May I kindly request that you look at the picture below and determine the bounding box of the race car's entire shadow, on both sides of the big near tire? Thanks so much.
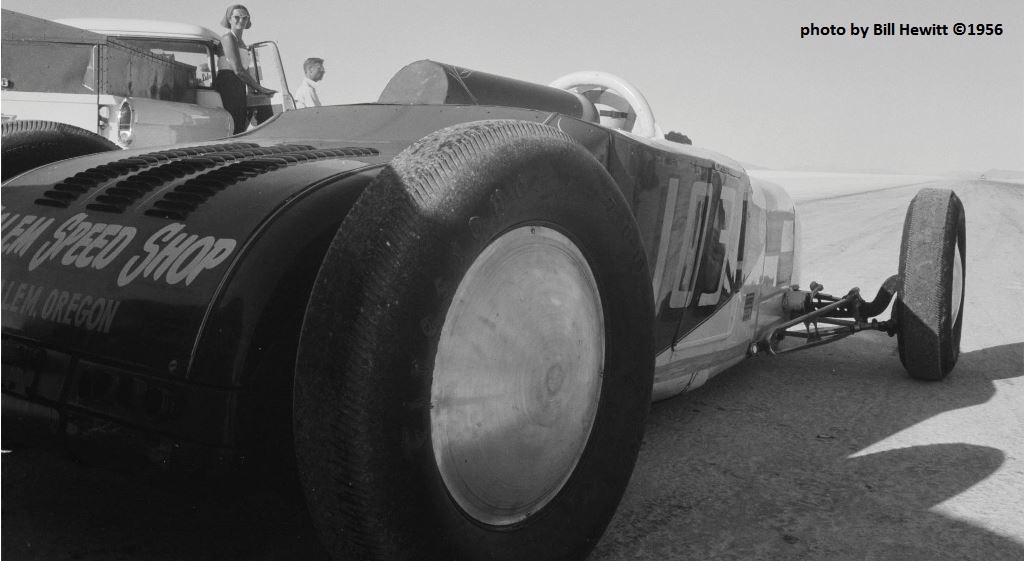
[2,335,1024,561]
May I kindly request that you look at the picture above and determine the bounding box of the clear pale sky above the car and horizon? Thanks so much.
[6,0,1024,174]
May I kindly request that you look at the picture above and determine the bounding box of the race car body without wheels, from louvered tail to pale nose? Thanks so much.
[2,62,799,456]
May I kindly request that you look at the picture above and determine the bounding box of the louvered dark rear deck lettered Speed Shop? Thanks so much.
[2,141,381,375]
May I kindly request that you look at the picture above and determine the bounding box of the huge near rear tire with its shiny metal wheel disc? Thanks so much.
[295,121,653,561]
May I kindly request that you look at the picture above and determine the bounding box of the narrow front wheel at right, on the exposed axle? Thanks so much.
[894,188,967,380]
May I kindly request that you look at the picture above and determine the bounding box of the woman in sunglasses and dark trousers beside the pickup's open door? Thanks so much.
[213,4,275,134]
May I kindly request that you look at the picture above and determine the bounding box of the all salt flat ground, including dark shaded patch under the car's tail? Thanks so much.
[2,172,1024,561]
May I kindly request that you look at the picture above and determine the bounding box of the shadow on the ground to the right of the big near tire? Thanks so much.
[591,334,1024,561]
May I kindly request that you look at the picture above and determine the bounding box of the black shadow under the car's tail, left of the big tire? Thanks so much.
[0,425,328,561]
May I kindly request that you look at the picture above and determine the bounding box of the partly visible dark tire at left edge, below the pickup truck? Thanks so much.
[0,120,119,181]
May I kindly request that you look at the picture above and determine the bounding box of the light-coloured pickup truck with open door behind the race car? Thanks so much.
[2,9,295,179]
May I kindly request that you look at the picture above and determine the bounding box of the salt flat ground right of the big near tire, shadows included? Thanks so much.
[591,173,1024,561]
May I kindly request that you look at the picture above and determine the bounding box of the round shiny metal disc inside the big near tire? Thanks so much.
[430,226,604,525]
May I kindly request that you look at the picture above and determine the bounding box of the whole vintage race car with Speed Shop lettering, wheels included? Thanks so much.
[2,60,965,560]
